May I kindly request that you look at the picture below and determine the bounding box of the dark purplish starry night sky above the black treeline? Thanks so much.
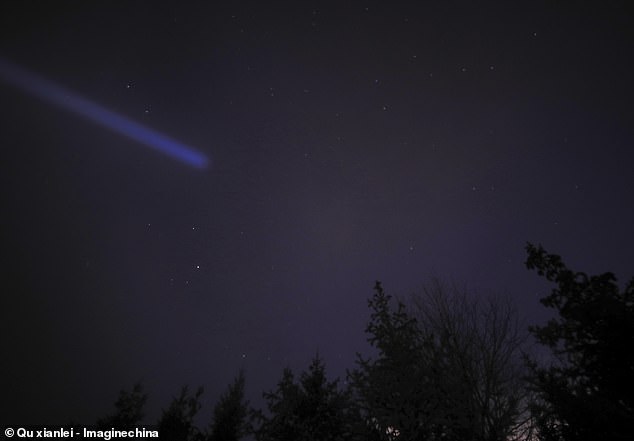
[0,1,634,424]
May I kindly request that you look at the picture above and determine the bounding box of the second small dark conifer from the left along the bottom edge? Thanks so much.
[158,386,204,441]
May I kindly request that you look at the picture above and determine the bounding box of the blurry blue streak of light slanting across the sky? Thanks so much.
[0,58,209,169]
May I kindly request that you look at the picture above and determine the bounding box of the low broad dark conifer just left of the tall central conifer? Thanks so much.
[253,356,351,441]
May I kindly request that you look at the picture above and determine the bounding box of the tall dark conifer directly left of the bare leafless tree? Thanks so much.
[349,281,444,440]
